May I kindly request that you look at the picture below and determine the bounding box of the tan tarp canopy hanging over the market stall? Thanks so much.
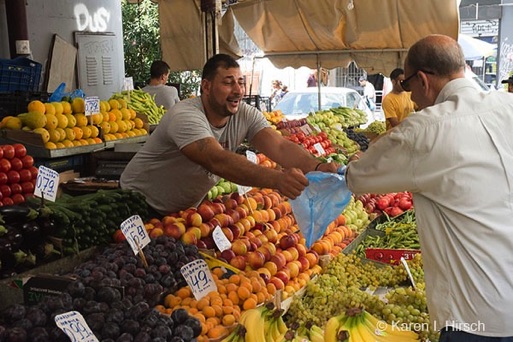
[159,0,459,74]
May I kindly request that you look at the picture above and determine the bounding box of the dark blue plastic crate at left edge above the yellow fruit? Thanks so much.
[0,57,42,92]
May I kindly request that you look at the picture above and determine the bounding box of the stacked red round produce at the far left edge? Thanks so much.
[0,144,38,206]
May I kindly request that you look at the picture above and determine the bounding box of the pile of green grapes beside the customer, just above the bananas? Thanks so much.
[284,253,438,341]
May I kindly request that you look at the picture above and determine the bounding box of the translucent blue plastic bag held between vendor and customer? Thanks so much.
[290,168,352,248]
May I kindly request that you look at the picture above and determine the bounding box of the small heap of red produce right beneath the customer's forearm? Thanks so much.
[358,191,413,217]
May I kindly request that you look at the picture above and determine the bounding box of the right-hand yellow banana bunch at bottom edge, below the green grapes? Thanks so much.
[324,309,420,342]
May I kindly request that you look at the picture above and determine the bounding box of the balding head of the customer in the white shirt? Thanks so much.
[404,34,465,109]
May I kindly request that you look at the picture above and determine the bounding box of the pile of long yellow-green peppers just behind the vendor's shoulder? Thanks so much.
[111,89,166,125]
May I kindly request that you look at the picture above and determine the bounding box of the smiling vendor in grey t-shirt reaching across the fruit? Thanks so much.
[120,54,339,215]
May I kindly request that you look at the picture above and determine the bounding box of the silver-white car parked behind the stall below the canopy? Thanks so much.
[273,87,374,124]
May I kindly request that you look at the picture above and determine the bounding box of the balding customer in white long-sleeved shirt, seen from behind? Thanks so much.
[346,35,513,342]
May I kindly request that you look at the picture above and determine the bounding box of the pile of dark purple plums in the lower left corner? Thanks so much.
[0,236,201,342]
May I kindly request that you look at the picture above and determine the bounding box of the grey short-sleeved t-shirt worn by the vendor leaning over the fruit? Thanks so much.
[120,97,269,214]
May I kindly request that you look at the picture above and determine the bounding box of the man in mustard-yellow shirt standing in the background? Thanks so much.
[381,68,415,130]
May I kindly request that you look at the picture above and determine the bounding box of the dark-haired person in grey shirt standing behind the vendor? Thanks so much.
[142,61,180,109]
